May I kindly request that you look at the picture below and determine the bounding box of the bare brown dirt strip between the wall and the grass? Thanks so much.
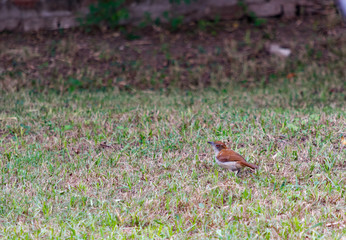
[0,14,345,92]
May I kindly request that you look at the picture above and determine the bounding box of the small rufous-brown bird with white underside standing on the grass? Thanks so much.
[208,141,258,174]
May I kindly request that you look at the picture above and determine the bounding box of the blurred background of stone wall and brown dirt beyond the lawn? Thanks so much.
[0,0,345,93]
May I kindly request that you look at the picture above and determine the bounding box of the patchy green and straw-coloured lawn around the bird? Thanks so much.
[0,66,346,239]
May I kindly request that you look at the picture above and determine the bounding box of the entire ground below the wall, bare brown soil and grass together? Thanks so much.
[0,14,346,239]
